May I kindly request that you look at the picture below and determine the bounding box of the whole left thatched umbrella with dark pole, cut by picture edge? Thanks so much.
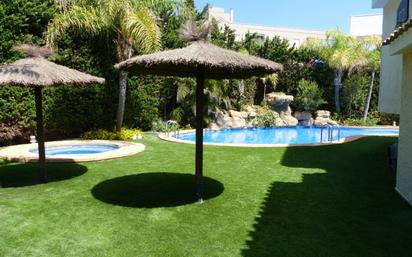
[0,45,104,182]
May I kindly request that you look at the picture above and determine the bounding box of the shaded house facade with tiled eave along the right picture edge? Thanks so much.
[372,0,412,205]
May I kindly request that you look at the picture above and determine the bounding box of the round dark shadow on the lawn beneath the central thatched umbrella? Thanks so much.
[92,172,224,208]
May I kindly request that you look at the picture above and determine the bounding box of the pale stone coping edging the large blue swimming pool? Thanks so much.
[159,126,399,148]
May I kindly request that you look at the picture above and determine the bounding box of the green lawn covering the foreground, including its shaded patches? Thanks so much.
[0,137,412,257]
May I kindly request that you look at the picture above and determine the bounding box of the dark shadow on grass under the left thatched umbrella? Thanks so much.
[0,163,87,188]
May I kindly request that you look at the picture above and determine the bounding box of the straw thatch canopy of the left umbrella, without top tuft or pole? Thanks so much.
[0,56,104,87]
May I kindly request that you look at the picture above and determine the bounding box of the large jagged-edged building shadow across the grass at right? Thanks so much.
[242,138,412,257]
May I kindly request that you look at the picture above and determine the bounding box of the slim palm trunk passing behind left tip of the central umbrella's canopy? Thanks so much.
[116,35,133,131]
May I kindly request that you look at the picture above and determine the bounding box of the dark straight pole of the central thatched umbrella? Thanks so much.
[196,70,205,203]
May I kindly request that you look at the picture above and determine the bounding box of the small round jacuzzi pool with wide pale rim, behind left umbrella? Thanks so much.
[0,140,145,162]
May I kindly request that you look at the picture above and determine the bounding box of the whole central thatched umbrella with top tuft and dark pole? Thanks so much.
[115,22,283,202]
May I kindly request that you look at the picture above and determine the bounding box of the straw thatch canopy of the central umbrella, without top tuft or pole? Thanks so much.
[115,40,283,79]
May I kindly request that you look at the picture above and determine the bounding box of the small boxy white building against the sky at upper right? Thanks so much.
[349,14,383,38]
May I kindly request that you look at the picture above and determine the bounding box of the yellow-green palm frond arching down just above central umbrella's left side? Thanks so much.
[121,8,160,53]
